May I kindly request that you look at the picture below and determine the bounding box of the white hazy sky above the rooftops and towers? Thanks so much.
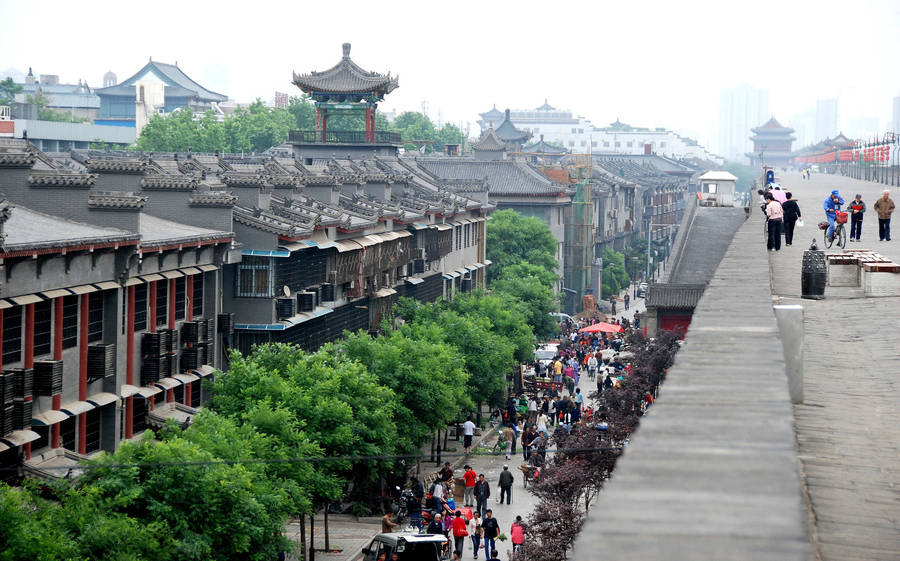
[0,0,900,149]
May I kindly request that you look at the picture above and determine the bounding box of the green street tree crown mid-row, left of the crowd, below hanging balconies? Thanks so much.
[334,324,473,452]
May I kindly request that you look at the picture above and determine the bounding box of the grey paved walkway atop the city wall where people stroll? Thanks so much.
[768,174,900,561]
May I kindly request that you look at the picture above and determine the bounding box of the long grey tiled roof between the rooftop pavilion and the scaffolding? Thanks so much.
[415,158,566,196]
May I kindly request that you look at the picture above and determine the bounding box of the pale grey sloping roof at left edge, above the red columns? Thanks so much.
[3,198,138,248]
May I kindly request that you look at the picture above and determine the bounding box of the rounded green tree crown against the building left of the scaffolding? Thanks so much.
[487,209,557,282]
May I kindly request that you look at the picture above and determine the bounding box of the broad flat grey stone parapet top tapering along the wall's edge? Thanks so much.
[572,211,810,561]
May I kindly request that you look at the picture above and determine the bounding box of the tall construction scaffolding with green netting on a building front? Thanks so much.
[563,154,599,314]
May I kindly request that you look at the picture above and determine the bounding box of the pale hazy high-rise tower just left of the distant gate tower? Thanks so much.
[718,84,771,160]
